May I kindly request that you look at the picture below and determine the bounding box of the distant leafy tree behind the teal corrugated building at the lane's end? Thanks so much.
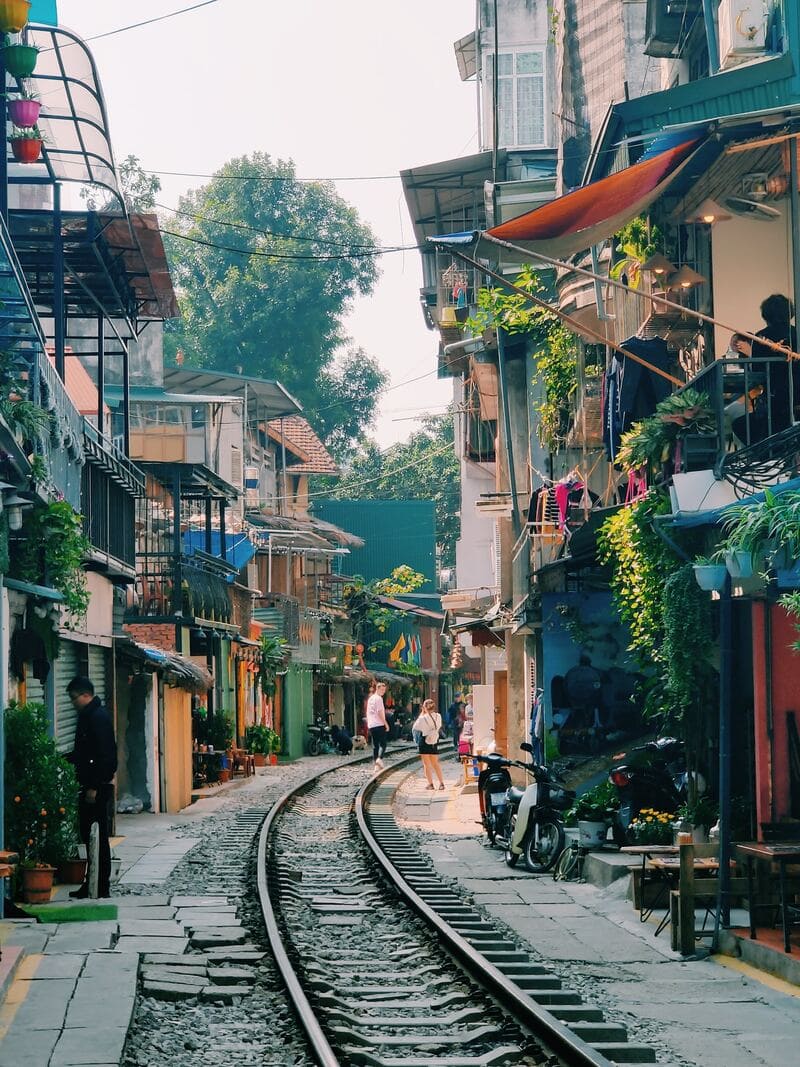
[315,416,461,567]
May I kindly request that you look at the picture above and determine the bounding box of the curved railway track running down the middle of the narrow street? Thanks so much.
[257,757,655,1067]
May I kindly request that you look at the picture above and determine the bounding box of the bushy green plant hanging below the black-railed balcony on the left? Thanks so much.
[12,500,90,625]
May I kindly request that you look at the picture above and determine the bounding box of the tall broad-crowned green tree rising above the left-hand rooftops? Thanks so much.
[164,152,380,451]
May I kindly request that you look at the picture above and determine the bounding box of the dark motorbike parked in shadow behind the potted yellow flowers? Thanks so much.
[608,737,706,845]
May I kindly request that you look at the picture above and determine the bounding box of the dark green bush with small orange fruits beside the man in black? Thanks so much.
[4,703,78,866]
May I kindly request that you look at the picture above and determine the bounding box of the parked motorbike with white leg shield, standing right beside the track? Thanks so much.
[477,742,575,874]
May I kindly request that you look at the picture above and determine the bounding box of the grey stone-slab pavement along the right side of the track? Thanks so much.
[398,761,800,1067]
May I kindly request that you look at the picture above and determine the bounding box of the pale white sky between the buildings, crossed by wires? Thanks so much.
[59,0,478,447]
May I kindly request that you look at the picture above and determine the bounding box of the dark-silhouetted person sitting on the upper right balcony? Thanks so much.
[732,293,800,445]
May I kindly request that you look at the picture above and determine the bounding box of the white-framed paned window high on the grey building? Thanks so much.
[486,50,546,148]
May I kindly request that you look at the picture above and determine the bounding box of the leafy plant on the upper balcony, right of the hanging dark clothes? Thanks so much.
[617,388,717,474]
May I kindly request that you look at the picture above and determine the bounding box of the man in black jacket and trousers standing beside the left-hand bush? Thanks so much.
[67,675,116,898]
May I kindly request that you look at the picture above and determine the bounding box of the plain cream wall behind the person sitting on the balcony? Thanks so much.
[711,201,793,359]
